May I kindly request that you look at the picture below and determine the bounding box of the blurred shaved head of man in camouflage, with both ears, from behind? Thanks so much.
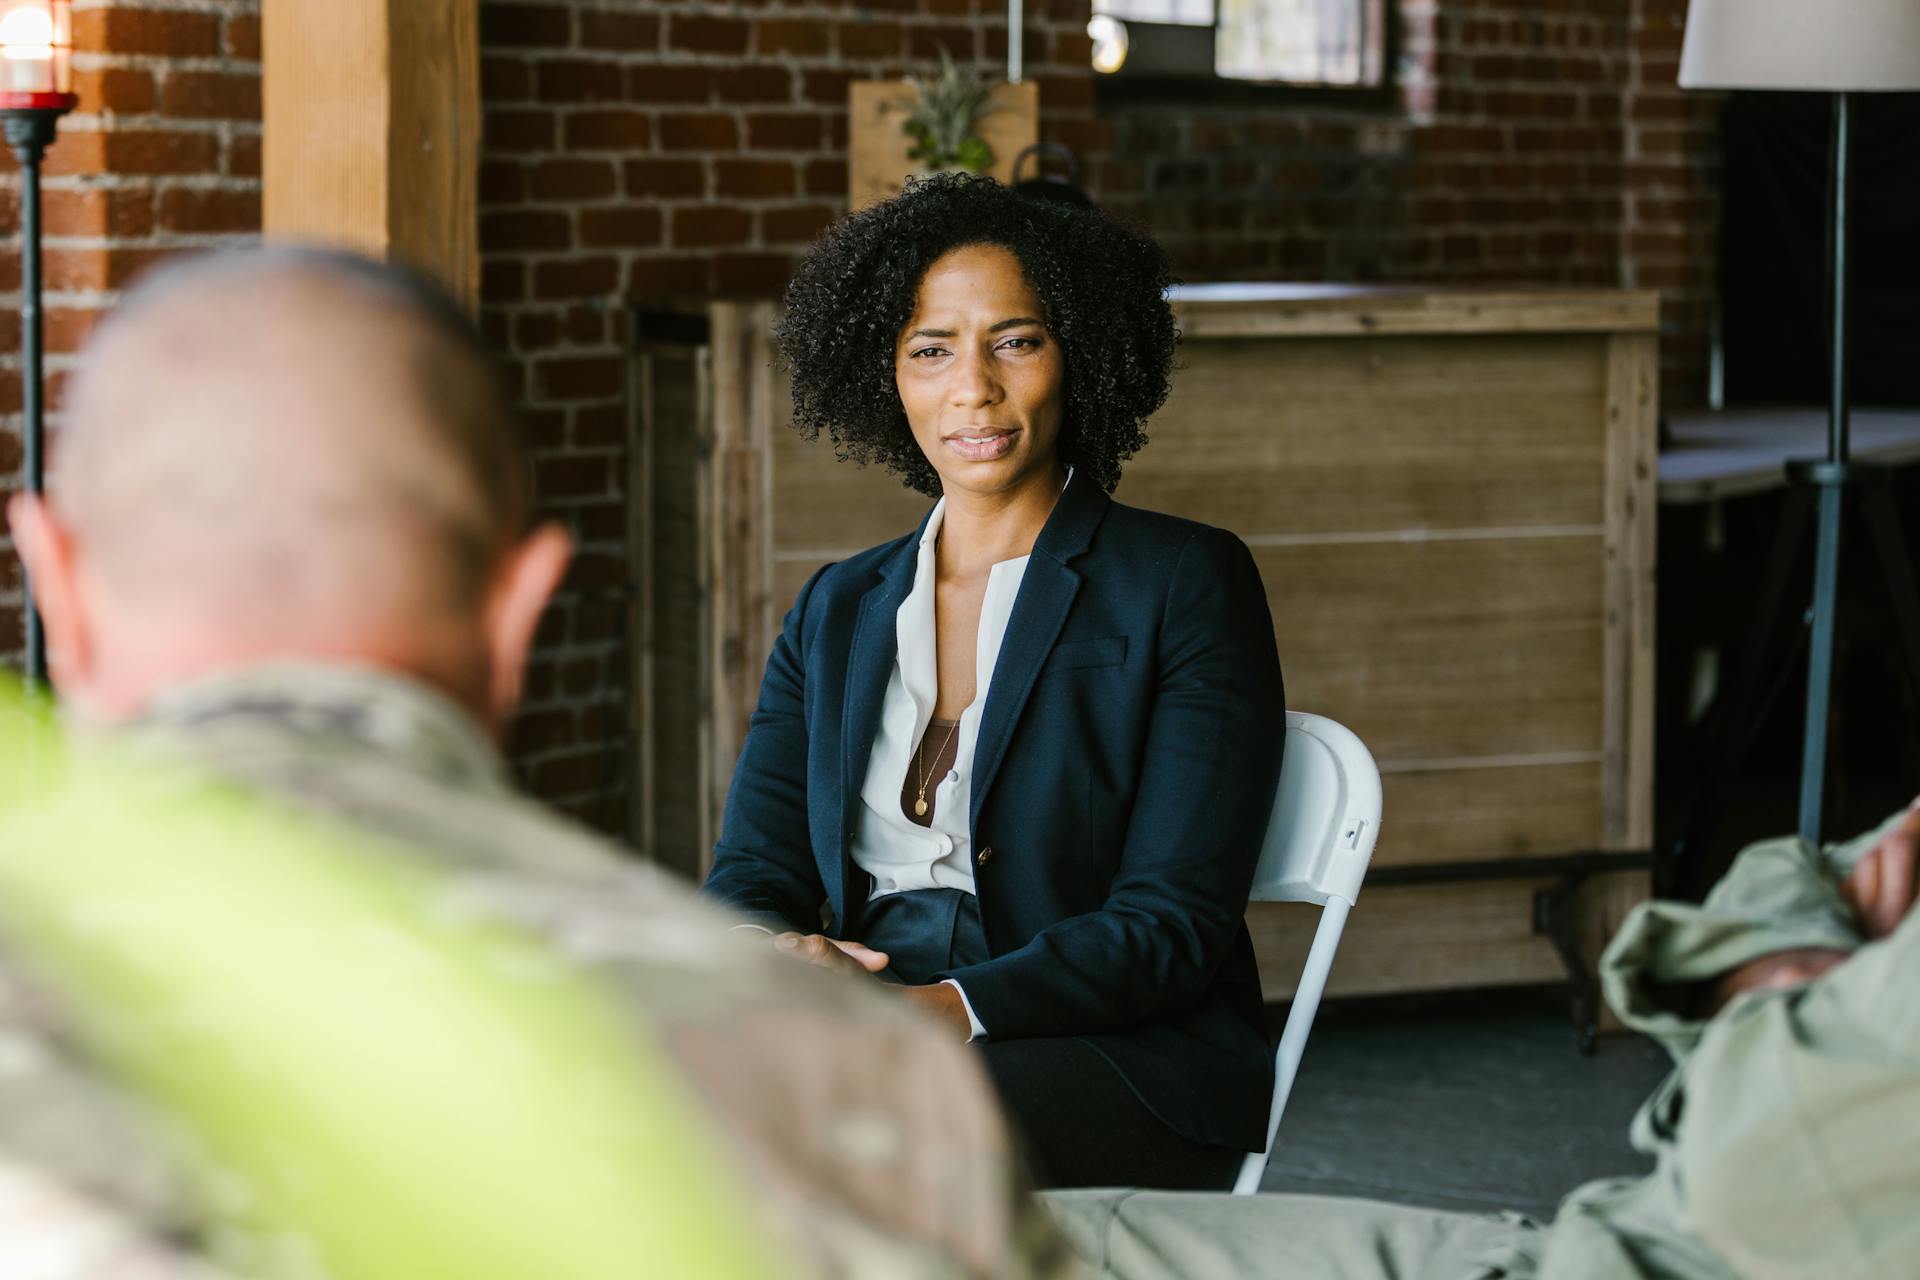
[10,249,568,723]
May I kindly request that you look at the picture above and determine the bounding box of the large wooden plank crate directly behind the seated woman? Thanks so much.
[636,286,1657,996]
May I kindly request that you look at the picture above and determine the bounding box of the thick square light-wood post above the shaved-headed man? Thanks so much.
[261,0,480,307]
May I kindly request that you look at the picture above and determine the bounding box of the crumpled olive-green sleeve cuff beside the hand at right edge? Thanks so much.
[1601,810,1905,1055]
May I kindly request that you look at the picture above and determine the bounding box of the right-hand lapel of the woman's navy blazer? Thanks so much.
[968,476,1112,823]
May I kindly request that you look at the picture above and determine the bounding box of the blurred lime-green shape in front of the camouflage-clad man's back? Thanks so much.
[0,685,778,1280]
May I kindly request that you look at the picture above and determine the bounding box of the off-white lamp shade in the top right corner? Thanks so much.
[1680,0,1920,92]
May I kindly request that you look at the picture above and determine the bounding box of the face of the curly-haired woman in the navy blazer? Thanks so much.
[893,244,1066,493]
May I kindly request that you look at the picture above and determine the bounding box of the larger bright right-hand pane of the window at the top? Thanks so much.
[1213,0,1382,84]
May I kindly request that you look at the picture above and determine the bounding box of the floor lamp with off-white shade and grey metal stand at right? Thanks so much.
[1680,0,1920,844]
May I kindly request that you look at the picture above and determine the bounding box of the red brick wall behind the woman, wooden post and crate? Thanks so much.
[0,0,1715,825]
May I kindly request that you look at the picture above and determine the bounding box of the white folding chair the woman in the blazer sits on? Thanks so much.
[1233,712,1380,1196]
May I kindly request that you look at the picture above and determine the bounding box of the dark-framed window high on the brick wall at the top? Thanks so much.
[1087,0,1386,90]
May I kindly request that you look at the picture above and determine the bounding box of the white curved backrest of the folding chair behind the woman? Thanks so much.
[1252,712,1380,906]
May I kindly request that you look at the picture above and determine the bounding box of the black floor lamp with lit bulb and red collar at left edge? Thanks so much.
[0,0,79,687]
